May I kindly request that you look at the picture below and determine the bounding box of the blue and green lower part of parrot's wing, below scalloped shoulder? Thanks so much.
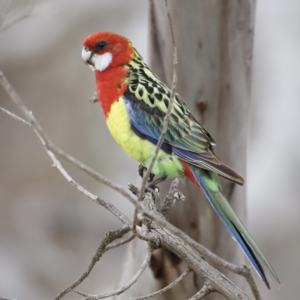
[123,92,244,184]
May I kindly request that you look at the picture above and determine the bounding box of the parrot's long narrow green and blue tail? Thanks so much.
[189,165,280,288]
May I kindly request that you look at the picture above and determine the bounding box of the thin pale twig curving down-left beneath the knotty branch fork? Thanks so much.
[80,250,151,300]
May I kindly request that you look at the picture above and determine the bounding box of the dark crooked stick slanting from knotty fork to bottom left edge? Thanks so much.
[54,226,130,300]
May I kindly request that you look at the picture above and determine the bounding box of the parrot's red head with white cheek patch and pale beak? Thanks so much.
[82,31,133,72]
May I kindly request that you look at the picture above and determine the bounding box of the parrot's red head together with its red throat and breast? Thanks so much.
[82,32,134,117]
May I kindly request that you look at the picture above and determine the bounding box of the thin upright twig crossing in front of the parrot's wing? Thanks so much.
[138,0,178,201]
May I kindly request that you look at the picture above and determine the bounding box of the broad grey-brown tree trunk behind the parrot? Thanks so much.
[115,0,255,300]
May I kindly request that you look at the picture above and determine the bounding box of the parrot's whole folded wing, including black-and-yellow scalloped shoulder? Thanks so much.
[123,69,244,184]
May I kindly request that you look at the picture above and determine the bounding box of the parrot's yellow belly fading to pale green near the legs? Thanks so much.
[106,97,183,177]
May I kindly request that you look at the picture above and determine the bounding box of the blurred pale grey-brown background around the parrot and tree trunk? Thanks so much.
[0,0,300,300]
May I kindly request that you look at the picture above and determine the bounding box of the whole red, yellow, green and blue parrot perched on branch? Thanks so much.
[81,31,280,289]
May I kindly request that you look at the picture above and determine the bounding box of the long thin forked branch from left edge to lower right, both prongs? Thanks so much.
[0,72,259,299]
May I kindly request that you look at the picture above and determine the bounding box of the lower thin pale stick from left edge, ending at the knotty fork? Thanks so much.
[0,107,131,227]
